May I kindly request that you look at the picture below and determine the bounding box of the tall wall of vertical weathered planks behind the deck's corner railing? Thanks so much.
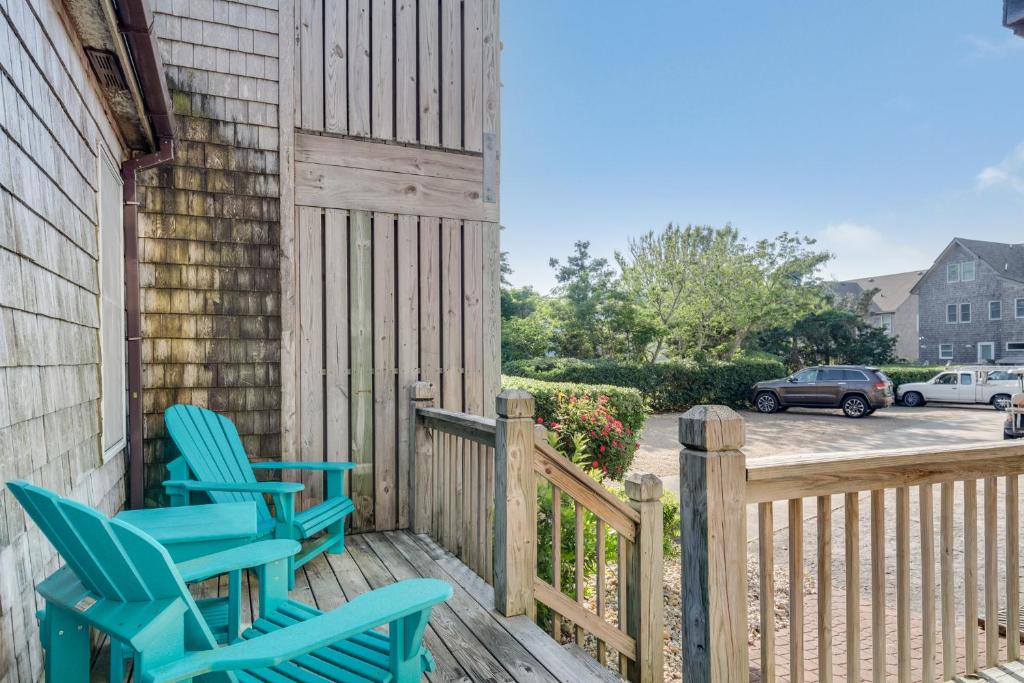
[281,0,500,529]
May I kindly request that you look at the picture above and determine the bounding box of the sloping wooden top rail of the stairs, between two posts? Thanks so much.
[534,425,640,542]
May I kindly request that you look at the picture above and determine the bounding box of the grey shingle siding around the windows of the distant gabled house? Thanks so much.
[918,244,1024,364]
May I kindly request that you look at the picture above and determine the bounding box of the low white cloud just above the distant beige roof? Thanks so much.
[816,221,935,280]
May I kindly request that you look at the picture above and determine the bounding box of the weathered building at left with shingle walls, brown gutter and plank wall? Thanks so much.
[0,0,500,681]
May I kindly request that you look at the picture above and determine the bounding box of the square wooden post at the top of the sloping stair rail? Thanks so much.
[495,389,537,617]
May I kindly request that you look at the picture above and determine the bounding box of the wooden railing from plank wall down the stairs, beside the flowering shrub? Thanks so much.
[411,382,665,681]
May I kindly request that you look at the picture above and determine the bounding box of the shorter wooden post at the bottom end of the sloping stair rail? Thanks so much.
[626,472,665,683]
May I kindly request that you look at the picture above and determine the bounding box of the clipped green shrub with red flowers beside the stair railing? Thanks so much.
[502,377,647,479]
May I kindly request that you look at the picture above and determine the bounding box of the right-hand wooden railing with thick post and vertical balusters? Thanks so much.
[680,407,1024,682]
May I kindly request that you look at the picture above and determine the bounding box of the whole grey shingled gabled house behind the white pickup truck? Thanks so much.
[912,238,1024,365]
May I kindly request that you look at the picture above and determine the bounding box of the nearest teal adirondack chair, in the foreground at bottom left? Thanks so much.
[7,481,452,683]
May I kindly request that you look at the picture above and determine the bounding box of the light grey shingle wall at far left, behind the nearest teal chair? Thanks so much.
[0,0,126,682]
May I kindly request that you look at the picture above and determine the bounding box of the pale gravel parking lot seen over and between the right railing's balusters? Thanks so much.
[633,405,1005,681]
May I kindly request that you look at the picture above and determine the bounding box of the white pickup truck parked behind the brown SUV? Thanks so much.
[896,368,1019,411]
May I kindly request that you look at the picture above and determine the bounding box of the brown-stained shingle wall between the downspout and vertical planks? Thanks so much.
[139,0,281,505]
